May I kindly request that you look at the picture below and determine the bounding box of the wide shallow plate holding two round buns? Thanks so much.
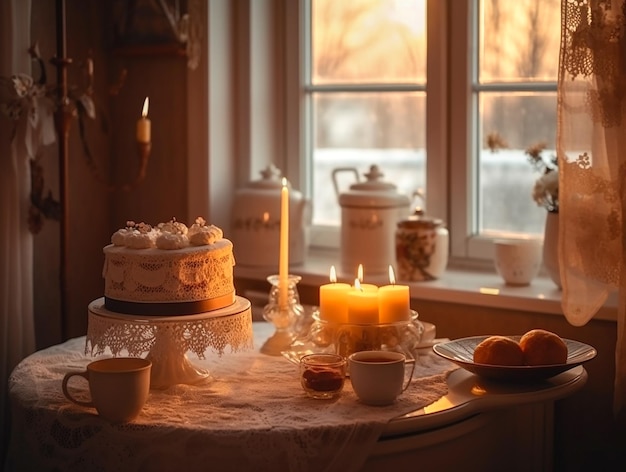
[433,336,597,382]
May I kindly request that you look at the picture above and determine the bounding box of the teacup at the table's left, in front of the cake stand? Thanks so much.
[62,357,152,423]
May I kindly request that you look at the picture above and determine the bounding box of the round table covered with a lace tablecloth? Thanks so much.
[7,323,587,472]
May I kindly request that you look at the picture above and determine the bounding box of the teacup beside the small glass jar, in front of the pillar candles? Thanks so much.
[348,351,415,405]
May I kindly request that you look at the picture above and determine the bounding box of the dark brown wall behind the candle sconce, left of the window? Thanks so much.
[31,0,187,348]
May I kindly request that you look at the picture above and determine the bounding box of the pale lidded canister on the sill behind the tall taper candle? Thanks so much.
[231,165,310,269]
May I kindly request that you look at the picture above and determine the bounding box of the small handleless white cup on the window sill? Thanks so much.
[494,238,543,285]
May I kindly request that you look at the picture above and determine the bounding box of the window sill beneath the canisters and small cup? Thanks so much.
[235,249,617,321]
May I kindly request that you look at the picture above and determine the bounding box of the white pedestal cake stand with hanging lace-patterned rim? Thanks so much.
[85,296,253,389]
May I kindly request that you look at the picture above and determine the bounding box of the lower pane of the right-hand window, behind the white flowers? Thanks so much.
[479,92,556,233]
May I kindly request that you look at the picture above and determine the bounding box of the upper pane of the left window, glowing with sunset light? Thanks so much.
[311,0,426,84]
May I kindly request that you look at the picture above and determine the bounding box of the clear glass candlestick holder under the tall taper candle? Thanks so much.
[261,275,304,356]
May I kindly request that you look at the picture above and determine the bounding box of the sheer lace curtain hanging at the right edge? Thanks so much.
[557,0,626,415]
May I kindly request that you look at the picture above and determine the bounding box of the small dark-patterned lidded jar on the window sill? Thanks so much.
[396,212,449,281]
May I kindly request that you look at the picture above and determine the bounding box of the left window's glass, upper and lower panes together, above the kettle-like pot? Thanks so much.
[306,0,426,232]
